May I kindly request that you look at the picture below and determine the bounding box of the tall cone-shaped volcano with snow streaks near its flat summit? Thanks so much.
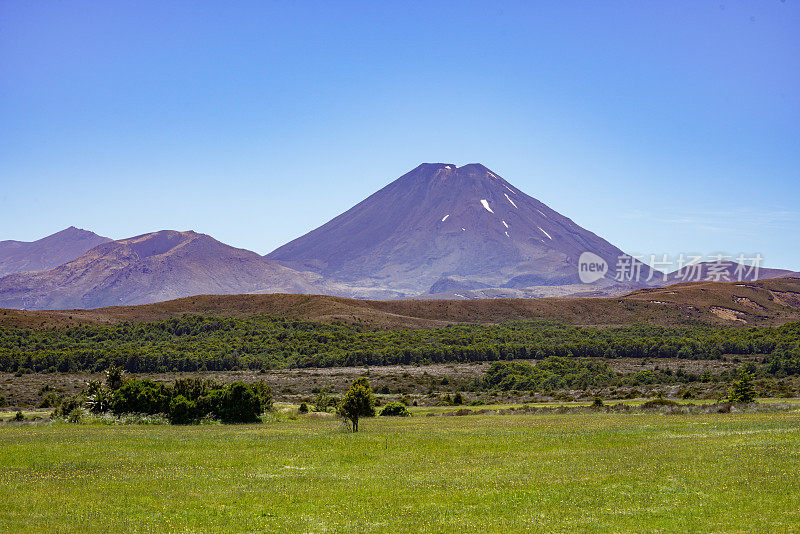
[267,163,636,295]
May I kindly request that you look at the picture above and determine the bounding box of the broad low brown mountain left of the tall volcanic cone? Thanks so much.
[0,230,323,309]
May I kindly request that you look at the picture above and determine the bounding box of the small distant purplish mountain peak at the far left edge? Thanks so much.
[0,226,111,277]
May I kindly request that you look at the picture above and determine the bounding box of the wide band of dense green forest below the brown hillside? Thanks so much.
[0,316,800,377]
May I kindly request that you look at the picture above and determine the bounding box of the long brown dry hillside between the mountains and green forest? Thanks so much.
[0,278,800,328]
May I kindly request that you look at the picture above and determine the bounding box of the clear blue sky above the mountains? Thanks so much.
[0,0,800,269]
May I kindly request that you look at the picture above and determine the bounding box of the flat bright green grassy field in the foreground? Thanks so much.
[0,412,800,532]
